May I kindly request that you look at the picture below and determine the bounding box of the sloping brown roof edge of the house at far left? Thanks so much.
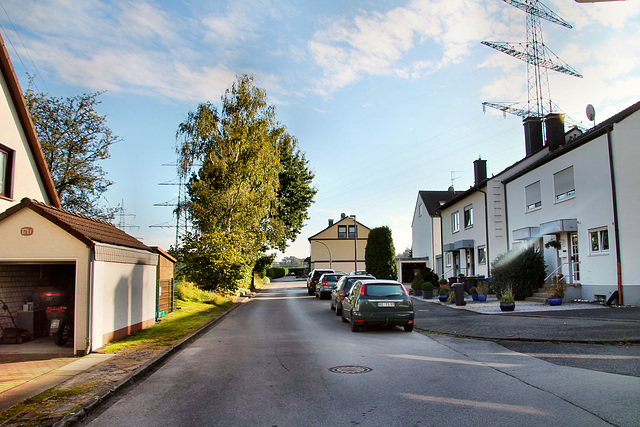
[0,35,61,208]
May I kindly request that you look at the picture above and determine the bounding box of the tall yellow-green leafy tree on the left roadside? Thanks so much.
[177,75,315,288]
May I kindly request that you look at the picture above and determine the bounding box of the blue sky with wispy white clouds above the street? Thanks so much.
[0,0,640,259]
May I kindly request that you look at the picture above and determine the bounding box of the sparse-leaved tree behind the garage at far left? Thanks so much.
[25,89,120,220]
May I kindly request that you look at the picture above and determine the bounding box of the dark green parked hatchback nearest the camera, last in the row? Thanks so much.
[342,280,415,332]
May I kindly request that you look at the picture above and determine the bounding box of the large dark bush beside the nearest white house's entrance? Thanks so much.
[490,247,546,300]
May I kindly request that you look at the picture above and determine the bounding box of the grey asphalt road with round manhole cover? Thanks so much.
[87,281,640,426]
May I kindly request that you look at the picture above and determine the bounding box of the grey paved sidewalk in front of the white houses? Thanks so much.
[413,297,640,343]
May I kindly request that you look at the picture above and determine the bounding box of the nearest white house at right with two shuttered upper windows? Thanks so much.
[504,102,640,305]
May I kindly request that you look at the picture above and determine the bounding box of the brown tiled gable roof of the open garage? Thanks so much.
[0,197,151,252]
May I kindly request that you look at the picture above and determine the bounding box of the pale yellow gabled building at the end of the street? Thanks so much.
[308,214,370,273]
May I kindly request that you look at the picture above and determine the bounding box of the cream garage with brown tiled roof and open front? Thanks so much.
[0,198,158,355]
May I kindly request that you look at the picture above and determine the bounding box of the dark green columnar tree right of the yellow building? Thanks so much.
[364,226,398,280]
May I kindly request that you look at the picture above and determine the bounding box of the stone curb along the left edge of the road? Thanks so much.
[53,289,260,427]
